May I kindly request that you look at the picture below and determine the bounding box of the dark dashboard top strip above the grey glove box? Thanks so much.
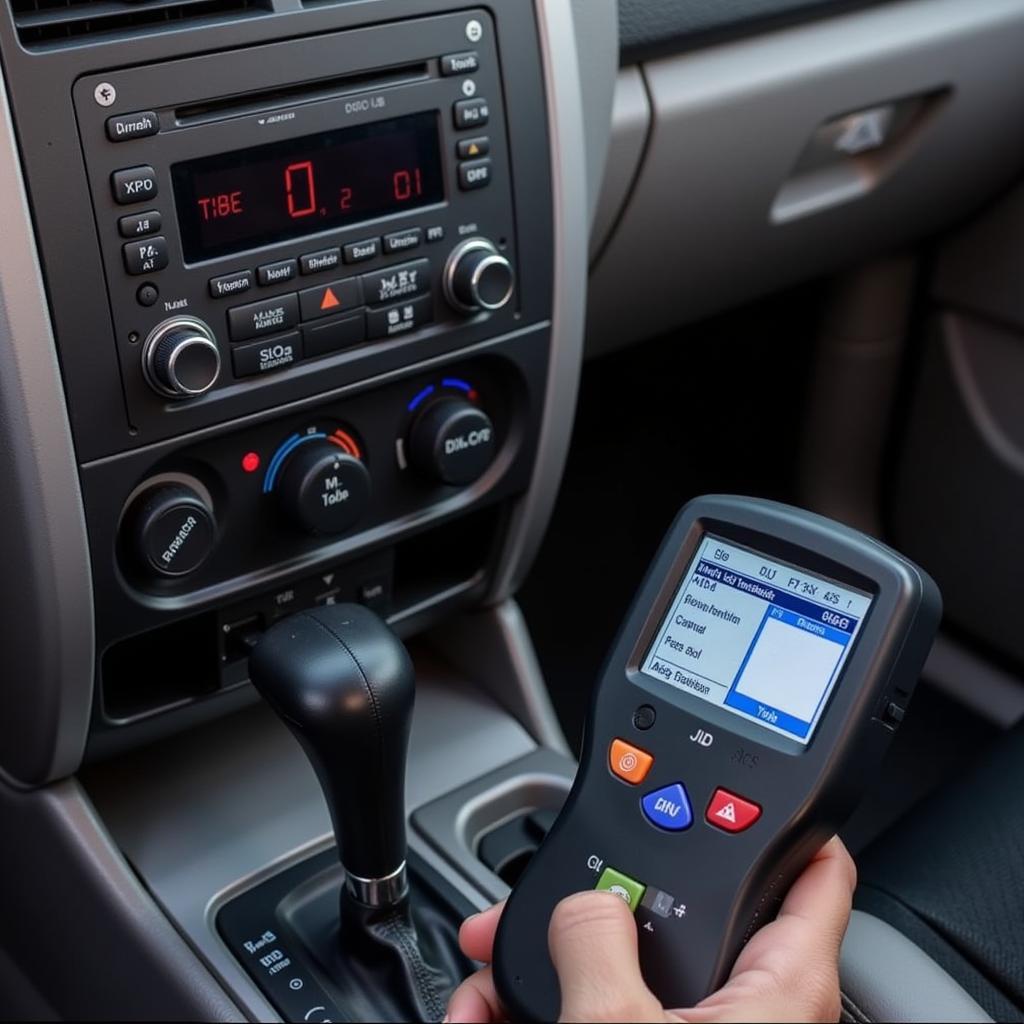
[618,0,883,63]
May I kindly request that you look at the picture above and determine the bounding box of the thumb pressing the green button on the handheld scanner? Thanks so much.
[548,892,665,1021]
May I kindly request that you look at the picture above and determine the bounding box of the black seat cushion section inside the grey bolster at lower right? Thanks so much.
[855,726,1024,1021]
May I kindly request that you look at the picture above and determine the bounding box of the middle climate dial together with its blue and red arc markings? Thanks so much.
[263,428,371,536]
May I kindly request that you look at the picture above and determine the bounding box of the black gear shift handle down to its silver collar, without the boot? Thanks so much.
[249,604,416,907]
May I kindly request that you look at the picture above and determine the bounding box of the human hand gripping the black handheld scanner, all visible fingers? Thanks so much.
[445,838,857,1024]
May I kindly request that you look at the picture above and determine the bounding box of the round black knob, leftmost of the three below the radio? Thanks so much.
[129,482,217,577]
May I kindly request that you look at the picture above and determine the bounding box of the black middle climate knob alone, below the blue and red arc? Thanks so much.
[276,437,370,535]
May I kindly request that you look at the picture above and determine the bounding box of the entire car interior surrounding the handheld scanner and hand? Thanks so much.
[0,0,1024,1022]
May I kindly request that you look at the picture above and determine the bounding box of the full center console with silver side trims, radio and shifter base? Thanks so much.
[0,0,615,1020]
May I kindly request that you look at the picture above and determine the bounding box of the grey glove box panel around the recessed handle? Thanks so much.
[587,0,1024,355]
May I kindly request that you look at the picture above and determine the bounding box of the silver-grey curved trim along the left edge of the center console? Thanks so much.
[0,48,94,784]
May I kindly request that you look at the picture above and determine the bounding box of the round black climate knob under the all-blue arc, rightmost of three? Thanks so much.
[409,397,497,485]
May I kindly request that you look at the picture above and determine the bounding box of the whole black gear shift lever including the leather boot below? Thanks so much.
[241,604,471,1021]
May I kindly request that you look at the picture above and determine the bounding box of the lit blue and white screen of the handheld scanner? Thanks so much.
[641,535,871,743]
